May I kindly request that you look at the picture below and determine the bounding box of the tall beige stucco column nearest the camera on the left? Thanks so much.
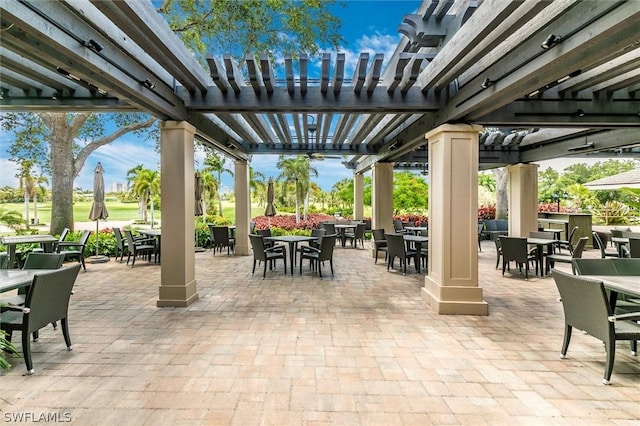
[157,121,198,307]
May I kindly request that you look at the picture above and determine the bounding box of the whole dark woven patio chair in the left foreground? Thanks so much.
[0,264,80,374]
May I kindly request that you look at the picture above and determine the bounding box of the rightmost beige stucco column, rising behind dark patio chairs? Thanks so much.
[507,164,538,237]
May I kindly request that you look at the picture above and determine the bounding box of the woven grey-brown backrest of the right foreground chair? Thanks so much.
[553,269,615,343]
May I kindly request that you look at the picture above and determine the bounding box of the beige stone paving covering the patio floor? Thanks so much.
[0,241,640,425]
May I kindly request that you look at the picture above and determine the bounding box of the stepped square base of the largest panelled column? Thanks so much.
[421,276,489,315]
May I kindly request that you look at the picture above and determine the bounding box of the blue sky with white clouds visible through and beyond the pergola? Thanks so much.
[0,0,421,191]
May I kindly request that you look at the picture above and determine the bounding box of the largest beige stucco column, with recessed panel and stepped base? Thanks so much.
[422,124,489,315]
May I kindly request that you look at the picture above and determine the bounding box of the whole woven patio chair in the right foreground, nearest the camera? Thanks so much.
[553,270,640,384]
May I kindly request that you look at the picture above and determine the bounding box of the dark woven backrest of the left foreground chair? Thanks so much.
[24,263,81,333]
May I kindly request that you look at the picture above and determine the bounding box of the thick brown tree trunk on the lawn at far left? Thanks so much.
[49,126,76,235]
